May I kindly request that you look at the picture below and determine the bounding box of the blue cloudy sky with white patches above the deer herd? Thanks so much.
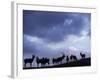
[23,10,91,57]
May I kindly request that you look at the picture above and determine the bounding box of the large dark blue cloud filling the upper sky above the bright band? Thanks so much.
[23,10,90,42]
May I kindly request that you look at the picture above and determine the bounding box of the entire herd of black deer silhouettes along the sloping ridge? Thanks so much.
[24,52,86,67]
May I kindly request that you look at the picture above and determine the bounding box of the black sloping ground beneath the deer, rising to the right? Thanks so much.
[23,58,91,69]
